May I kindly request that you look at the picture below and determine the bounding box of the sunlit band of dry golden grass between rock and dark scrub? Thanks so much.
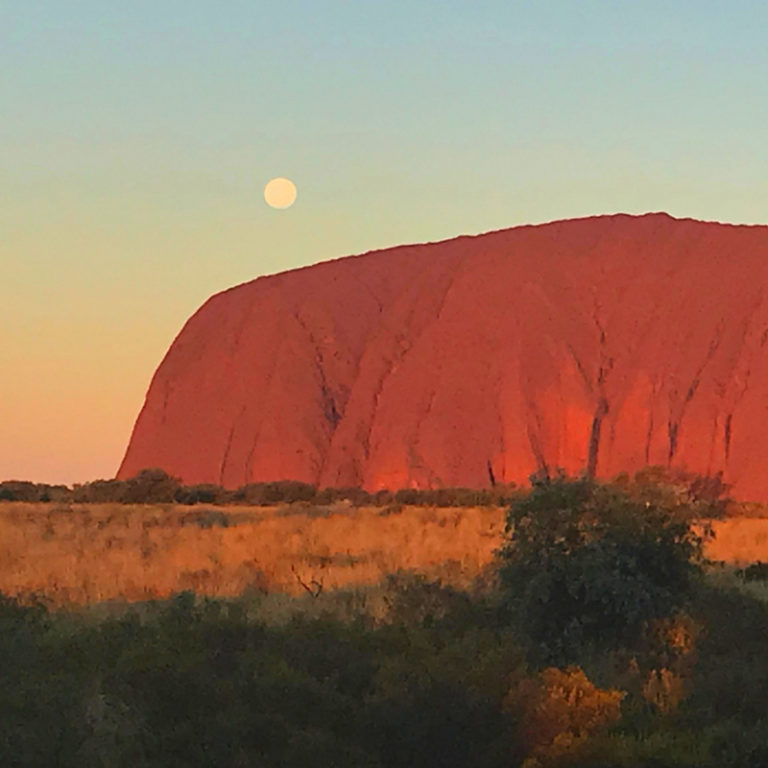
[0,502,768,605]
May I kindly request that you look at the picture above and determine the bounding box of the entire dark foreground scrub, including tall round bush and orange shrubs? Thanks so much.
[0,477,768,768]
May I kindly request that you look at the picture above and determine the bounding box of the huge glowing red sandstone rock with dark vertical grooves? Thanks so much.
[118,214,768,501]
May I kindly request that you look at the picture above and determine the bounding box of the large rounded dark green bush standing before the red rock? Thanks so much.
[498,476,702,664]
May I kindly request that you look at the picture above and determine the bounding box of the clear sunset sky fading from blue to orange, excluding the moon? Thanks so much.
[0,0,768,484]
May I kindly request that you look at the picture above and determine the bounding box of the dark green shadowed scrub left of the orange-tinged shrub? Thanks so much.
[0,593,522,768]
